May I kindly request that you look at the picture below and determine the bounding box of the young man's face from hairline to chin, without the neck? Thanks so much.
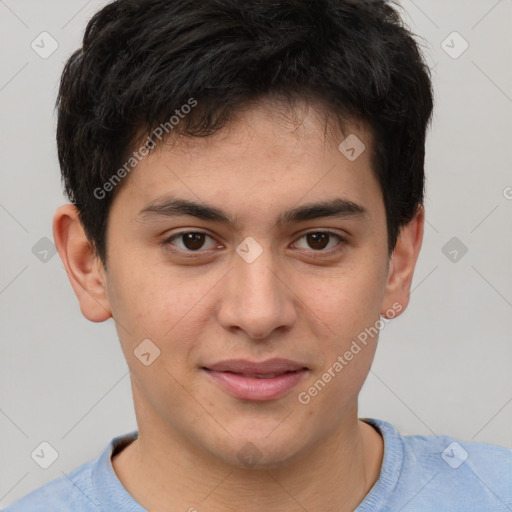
[55,99,420,465]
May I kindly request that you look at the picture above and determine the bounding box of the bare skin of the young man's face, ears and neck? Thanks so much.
[53,101,424,512]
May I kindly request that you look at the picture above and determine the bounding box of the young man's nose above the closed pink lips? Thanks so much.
[218,243,297,340]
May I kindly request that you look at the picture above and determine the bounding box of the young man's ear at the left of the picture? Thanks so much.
[53,204,112,322]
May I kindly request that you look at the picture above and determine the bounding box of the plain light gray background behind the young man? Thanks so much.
[0,0,512,507]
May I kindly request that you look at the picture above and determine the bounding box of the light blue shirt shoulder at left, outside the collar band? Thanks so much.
[4,461,100,512]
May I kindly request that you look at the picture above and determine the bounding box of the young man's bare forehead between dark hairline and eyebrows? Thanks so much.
[109,102,380,223]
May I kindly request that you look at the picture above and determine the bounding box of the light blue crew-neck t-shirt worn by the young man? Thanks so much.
[4,418,512,512]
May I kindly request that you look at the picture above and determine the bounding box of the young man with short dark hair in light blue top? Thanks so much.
[7,0,512,512]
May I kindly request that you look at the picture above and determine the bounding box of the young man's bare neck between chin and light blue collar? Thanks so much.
[112,404,383,512]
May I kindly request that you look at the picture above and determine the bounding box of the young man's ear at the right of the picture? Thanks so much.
[381,206,425,318]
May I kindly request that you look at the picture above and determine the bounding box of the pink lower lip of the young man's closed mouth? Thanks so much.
[205,369,307,400]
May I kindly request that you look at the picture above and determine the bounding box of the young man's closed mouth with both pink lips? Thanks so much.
[201,359,309,401]
